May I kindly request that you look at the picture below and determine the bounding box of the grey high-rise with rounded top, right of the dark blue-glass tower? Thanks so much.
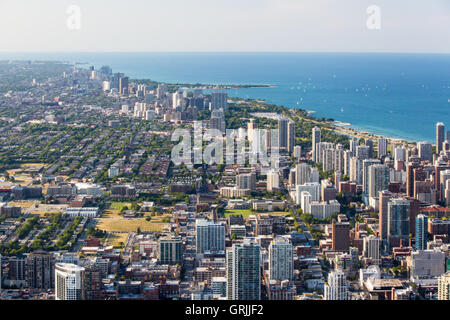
[269,237,294,281]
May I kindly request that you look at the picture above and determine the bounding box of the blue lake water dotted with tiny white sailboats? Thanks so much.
[0,53,450,142]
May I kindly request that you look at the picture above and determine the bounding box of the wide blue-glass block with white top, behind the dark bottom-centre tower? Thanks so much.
[195,219,225,253]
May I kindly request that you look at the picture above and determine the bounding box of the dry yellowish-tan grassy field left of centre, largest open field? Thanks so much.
[97,215,168,232]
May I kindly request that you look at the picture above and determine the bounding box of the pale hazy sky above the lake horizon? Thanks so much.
[0,0,450,53]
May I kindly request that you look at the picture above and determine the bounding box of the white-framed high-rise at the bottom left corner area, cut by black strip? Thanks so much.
[55,263,84,300]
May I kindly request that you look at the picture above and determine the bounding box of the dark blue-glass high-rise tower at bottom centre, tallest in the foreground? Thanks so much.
[227,238,261,300]
